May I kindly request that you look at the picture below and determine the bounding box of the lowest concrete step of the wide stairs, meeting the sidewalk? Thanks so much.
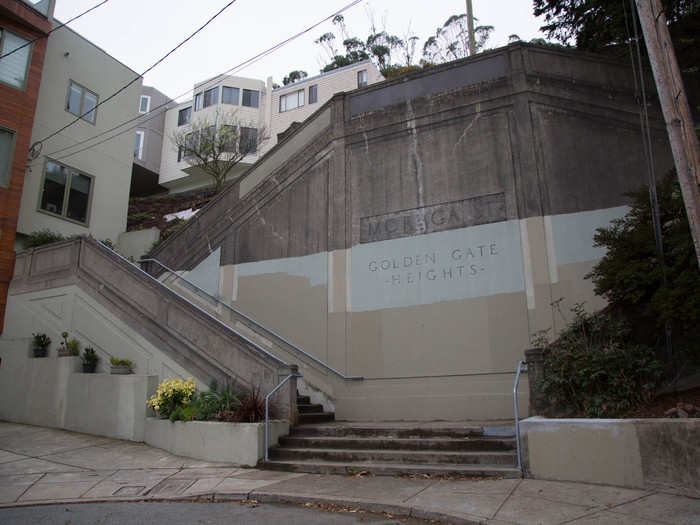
[258,460,520,478]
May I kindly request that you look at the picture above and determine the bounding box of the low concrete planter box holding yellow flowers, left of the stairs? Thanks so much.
[145,417,289,467]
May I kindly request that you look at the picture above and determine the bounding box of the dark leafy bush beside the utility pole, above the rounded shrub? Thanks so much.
[586,172,700,354]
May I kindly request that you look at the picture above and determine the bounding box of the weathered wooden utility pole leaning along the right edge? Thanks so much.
[635,0,700,266]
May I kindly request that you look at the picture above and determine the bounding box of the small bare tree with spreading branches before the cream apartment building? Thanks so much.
[170,111,268,193]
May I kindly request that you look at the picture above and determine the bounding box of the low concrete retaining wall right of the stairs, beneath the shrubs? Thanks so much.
[520,417,700,496]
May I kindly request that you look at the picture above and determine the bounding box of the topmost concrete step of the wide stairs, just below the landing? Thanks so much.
[290,423,494,439]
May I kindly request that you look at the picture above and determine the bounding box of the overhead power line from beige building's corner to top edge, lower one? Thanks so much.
[47,0,362,160]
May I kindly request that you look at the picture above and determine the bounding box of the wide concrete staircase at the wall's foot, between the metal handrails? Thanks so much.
[261,396,520,478]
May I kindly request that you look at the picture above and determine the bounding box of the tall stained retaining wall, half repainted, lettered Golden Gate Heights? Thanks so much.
[146,44,672,419]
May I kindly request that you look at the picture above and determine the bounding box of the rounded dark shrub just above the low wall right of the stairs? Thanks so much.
[540,304,662,417]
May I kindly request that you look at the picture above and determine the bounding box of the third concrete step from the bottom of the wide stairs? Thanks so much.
[280,434,515,452]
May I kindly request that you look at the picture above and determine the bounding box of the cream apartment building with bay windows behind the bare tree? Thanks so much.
[159,60,384,193]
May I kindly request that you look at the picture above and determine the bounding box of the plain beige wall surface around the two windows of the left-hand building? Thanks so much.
[18,24,141,241]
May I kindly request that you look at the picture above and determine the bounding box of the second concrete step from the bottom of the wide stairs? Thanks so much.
[270,447,516,467]
